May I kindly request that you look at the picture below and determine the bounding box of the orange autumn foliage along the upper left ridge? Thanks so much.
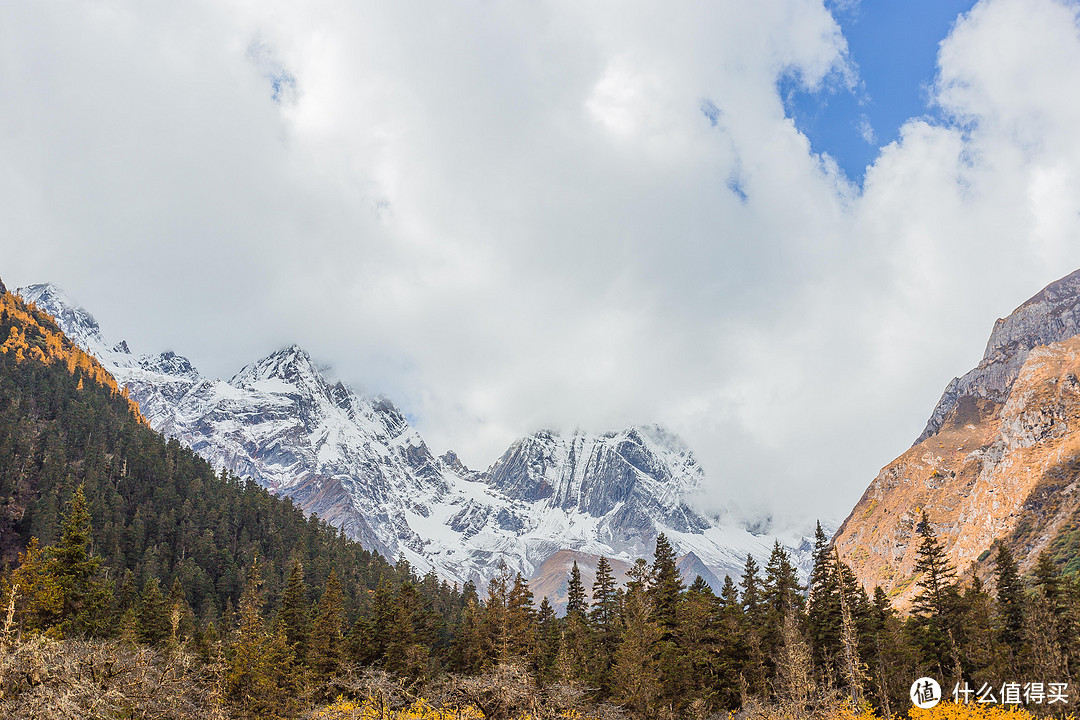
[0,293,150,425]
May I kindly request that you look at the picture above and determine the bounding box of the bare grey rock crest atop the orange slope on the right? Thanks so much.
[916,270,1080,443]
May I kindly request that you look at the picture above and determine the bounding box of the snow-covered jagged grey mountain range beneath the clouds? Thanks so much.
[17,285,809,585]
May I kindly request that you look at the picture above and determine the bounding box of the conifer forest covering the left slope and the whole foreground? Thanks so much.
[0,286,1080,720]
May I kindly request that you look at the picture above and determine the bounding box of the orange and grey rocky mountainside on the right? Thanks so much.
[835,273,1080,608]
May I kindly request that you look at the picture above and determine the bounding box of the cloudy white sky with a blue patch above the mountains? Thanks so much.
[0,0,1080,528]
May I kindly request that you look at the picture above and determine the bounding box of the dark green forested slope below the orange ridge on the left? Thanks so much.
[0,306,451,634]
